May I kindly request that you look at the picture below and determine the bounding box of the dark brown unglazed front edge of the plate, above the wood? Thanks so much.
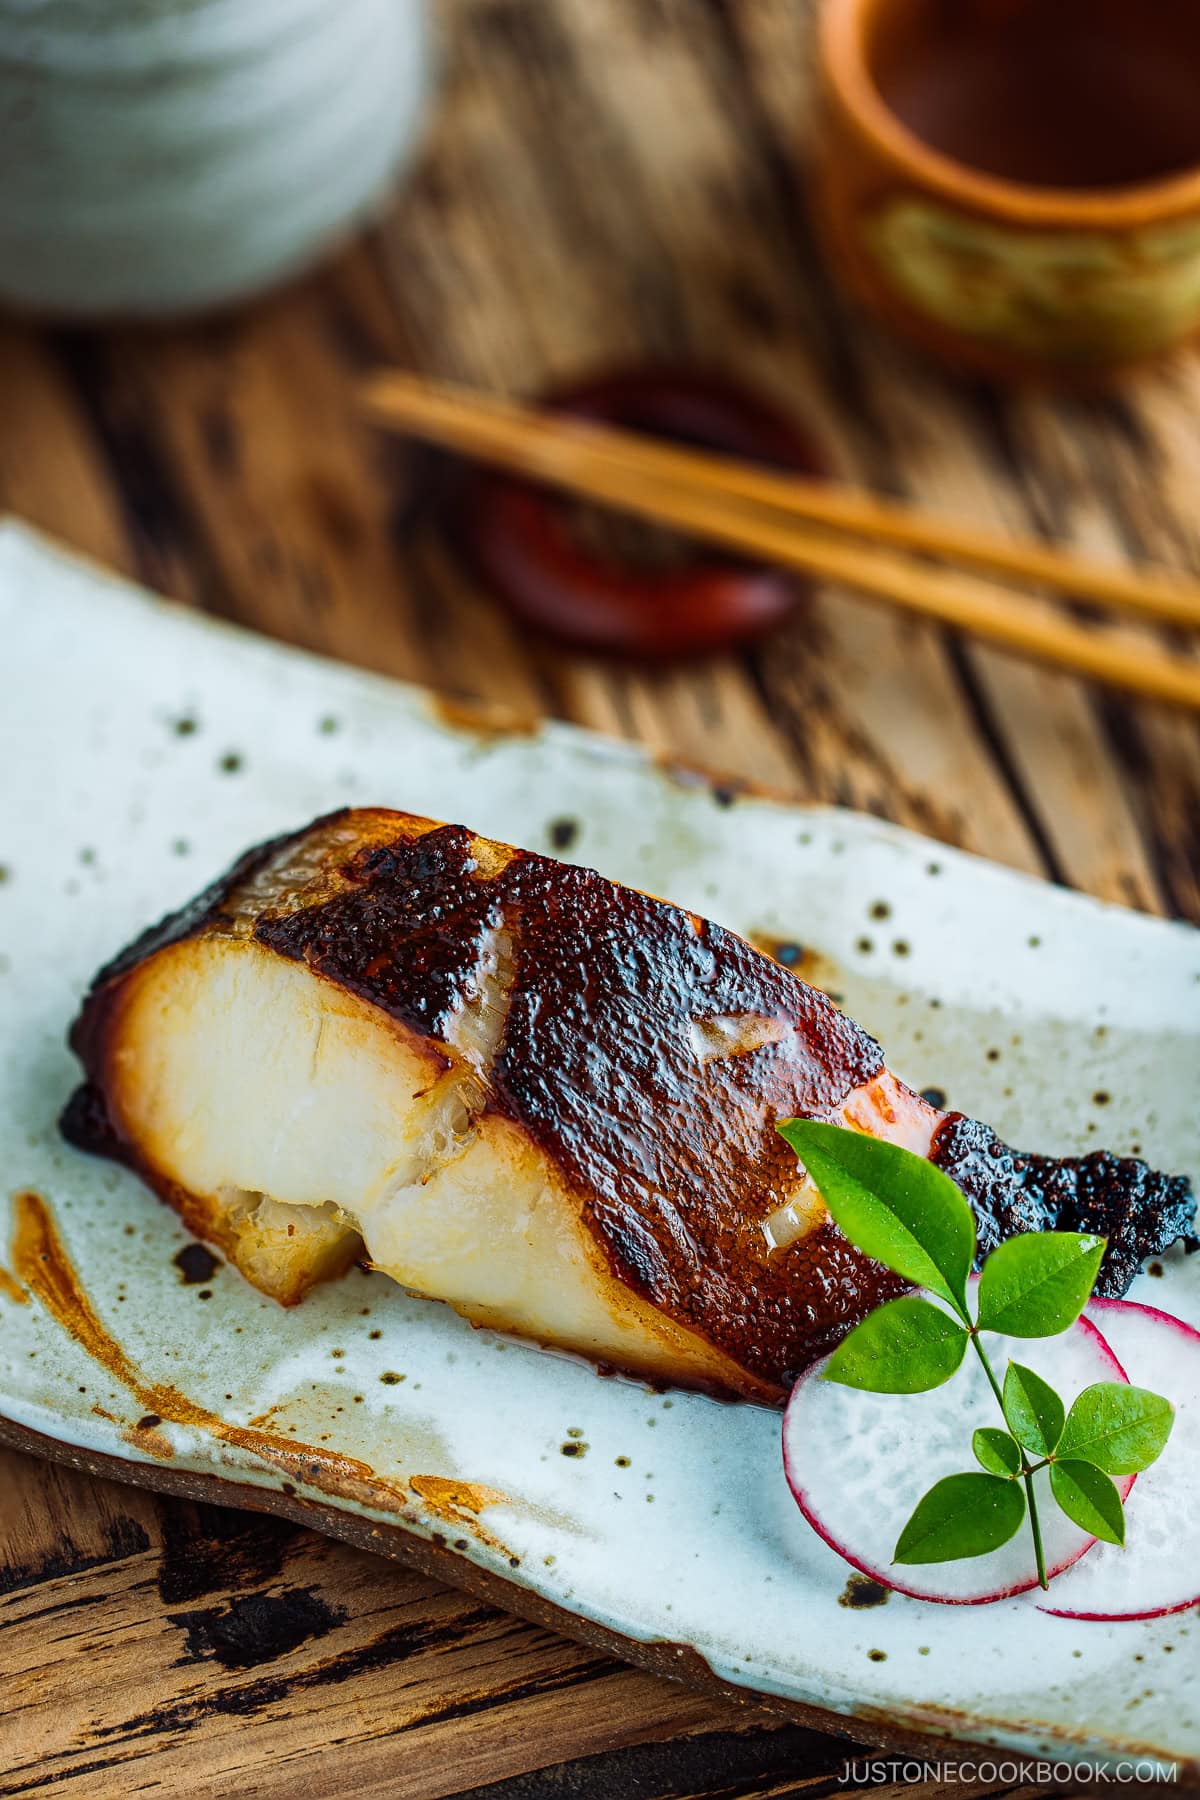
[0,1415,1200,1800]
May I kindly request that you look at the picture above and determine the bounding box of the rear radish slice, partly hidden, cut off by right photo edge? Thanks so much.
[1040,1300,1200,1620]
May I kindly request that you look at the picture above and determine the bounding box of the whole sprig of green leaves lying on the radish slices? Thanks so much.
[779,1120,1175,1588]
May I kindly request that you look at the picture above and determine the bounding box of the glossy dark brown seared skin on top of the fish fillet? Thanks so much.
[56,814,900,1400]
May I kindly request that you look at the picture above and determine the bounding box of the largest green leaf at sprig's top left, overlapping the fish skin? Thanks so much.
[777,1120,975,1318]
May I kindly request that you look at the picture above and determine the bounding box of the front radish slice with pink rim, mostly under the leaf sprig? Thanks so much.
[783,1319,1130,1606]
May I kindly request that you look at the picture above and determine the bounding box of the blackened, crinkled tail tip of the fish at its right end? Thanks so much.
[930,1112,1198,1300]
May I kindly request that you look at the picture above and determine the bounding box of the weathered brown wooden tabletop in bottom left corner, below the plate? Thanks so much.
[0,1451,788,1800]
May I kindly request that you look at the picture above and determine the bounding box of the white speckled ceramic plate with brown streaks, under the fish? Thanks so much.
[0,526,1200,1773]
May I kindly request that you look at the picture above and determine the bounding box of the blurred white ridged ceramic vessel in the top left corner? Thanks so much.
[0,0,437,317]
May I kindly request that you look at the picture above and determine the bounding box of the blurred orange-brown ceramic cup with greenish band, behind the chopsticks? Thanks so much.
[817,0,1200,378]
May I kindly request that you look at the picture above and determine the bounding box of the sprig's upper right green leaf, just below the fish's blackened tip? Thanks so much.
[979,1231,1105,1337]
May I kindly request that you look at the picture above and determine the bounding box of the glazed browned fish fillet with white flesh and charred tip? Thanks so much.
[63,808,1193,1402]
